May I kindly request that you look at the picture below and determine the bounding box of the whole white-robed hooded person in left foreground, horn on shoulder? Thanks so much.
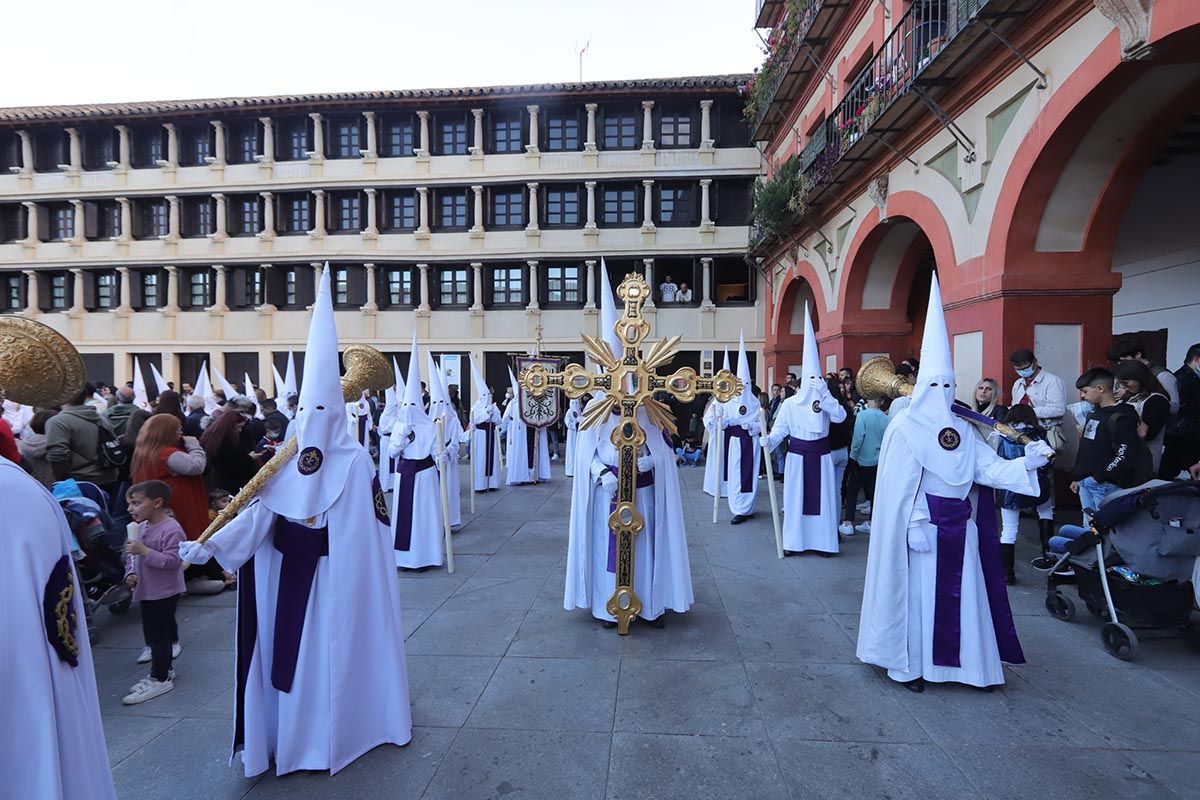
[180,267,412,777]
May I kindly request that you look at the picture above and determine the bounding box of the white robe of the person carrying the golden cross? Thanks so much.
[563,401,694,621]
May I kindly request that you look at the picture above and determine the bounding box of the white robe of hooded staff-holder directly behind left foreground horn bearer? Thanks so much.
[391,422,445,570]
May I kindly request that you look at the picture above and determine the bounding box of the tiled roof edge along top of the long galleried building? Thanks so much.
[0,74,750,124]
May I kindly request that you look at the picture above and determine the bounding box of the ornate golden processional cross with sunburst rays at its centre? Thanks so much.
[518,272,742,634]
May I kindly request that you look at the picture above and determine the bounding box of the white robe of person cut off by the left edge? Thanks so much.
[0,457,116,800]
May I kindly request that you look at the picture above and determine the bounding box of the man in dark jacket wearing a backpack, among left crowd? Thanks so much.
[46,384,124,497]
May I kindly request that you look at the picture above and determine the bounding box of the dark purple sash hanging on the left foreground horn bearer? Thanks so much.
[271,517,329,692]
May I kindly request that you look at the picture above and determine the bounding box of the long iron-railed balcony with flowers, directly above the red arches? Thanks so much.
[751,0,1042,249]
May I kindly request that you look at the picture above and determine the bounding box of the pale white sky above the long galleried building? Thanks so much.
[0,0,762,107]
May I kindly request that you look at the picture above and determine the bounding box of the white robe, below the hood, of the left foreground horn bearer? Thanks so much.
[205,455,412,777]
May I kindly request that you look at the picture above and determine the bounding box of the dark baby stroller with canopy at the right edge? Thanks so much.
[1045,480,1200,661]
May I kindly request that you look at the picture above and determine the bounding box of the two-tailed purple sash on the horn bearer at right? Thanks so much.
[925,491,1025,667]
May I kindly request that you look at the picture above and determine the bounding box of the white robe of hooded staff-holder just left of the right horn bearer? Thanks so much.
[767,392,846,553]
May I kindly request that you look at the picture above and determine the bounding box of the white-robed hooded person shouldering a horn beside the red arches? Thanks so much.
[857,275,1052,692]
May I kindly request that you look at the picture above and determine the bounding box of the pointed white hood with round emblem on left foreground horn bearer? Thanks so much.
[258,267,360,519]
